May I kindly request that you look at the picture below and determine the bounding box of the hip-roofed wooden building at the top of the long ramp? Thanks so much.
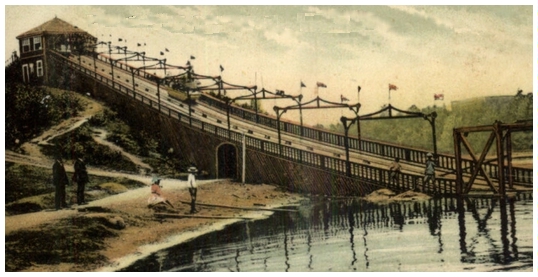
[17,17,97,84]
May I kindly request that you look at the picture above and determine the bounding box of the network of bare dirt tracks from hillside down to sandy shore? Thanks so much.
[4,89,301,272]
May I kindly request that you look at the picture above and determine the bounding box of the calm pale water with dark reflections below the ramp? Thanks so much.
[123,194,533,272]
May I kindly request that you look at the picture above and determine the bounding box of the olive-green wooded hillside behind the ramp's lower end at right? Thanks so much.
[329,93,532,153]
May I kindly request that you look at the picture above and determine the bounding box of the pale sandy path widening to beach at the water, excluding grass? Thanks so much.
[5,175,302,272]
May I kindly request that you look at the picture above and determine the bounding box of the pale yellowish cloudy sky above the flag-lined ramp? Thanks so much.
[5,2,533,124]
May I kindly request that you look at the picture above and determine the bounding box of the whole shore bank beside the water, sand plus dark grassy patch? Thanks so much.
[6,177,305,272]
